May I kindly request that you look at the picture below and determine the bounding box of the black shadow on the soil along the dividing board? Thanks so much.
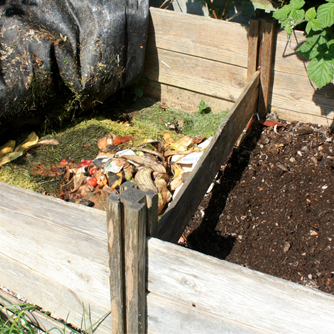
[187,123,263,259]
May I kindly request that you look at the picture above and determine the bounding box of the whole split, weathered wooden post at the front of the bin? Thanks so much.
[107,187,158,334]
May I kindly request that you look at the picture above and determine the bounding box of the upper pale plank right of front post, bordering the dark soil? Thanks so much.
[148,238,334,334]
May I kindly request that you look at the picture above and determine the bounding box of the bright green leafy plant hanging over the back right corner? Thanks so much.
[273,0,334,88]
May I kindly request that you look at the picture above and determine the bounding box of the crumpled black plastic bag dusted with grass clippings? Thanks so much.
[0,0,149,127]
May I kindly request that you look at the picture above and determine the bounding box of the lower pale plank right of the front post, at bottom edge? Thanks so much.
[147,292,271,334]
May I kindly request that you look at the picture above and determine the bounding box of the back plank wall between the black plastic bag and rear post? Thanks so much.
[144,8,248,112]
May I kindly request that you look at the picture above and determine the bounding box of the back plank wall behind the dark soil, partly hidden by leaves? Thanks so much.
[270,27,334,126]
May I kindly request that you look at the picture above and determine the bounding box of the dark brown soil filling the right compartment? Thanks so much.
[183,117,334,294]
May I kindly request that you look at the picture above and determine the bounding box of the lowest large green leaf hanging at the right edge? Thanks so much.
[307,58,334,88]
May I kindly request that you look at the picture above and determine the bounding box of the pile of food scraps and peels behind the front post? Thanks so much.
[52,133,210,214]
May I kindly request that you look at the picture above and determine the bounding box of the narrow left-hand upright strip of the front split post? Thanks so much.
[106,194,126,334]
